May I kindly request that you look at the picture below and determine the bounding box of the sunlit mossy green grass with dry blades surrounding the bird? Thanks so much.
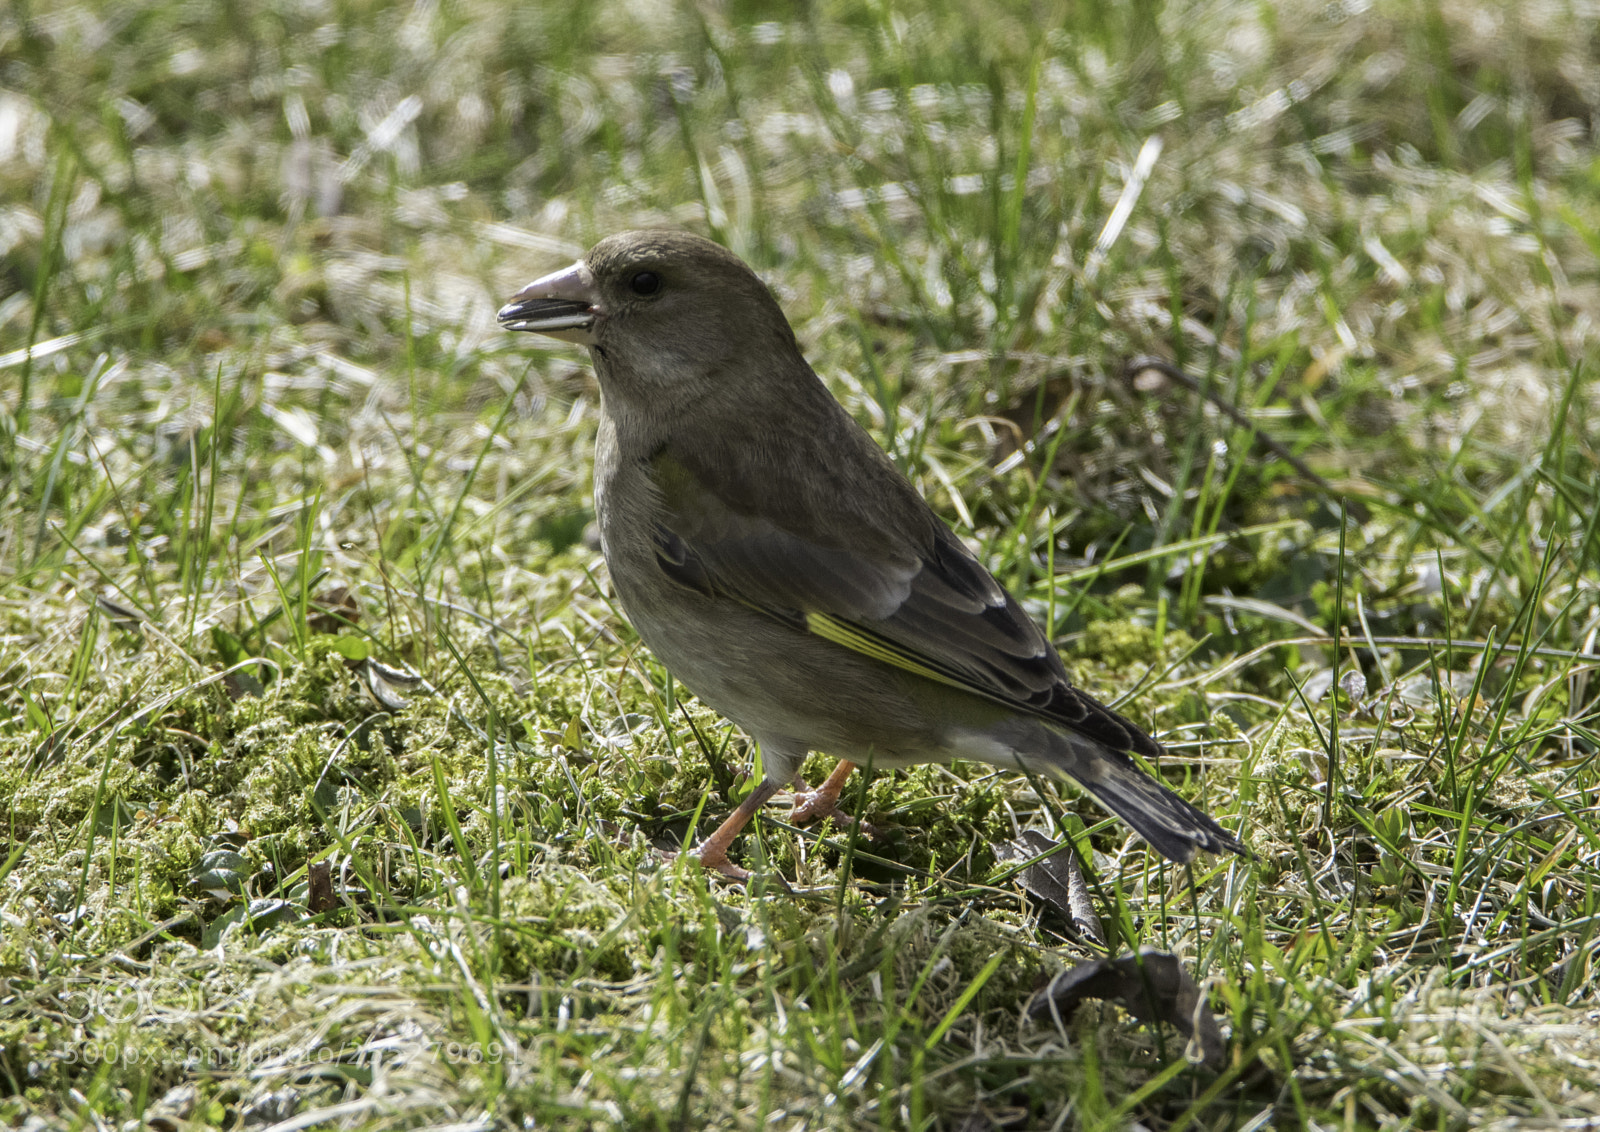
[0,0,1600,1129]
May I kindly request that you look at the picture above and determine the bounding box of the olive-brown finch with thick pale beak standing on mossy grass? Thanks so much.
[498,230,1250,881]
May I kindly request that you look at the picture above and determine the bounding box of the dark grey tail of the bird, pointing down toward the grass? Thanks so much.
[1029,726,1250,863]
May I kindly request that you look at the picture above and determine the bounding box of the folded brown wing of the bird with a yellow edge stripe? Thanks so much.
[653,440,1162,758]
